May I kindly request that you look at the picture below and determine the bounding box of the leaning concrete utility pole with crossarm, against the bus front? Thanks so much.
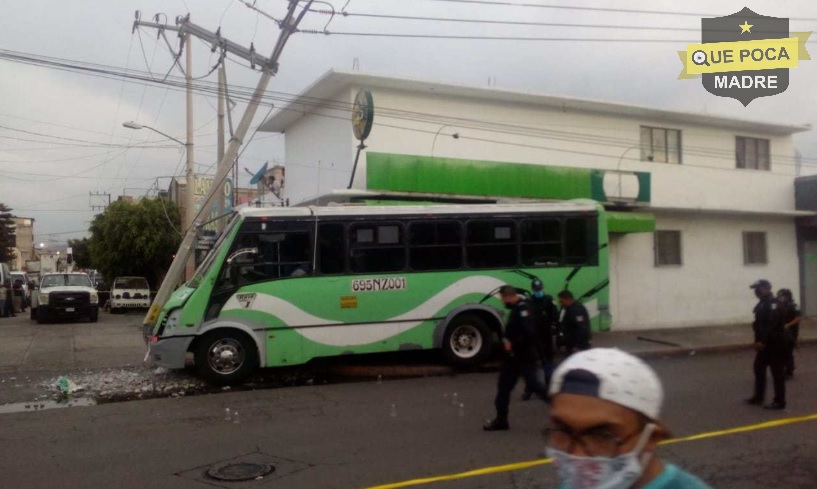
[142,0,314,340]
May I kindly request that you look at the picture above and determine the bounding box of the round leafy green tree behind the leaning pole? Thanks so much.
[88,199,181,287]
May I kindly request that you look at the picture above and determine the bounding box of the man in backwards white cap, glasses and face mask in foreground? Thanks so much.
[544,348,711,489]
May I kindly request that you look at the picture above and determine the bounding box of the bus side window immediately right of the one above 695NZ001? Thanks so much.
[409,221,462,271]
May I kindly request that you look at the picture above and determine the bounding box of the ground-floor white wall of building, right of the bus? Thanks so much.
[610,214,800,330]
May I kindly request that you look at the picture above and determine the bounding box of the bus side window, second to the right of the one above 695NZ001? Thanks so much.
[465,220,518,268]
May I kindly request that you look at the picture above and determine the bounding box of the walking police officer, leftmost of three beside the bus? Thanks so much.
[483,285,547,431]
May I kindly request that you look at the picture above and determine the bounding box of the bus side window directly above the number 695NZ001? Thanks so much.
[349,223,406,273]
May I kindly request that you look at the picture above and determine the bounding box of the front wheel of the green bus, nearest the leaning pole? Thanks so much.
[193,329,258,386]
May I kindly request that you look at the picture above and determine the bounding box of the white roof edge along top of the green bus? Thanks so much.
[239,201,598,217]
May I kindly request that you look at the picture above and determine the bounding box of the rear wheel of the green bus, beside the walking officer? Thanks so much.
[443,314,492,365]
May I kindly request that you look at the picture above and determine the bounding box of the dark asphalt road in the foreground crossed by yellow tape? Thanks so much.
[0,347,817,489]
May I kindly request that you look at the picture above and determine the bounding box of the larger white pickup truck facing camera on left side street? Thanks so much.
[31,273,99,323]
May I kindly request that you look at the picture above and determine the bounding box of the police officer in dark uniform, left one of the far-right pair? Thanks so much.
[746,279,786,409]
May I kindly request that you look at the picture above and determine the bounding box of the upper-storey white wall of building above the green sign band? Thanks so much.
[318,83,794,211]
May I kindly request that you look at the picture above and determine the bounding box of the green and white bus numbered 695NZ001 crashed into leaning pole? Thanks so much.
[148,201,609,384]
